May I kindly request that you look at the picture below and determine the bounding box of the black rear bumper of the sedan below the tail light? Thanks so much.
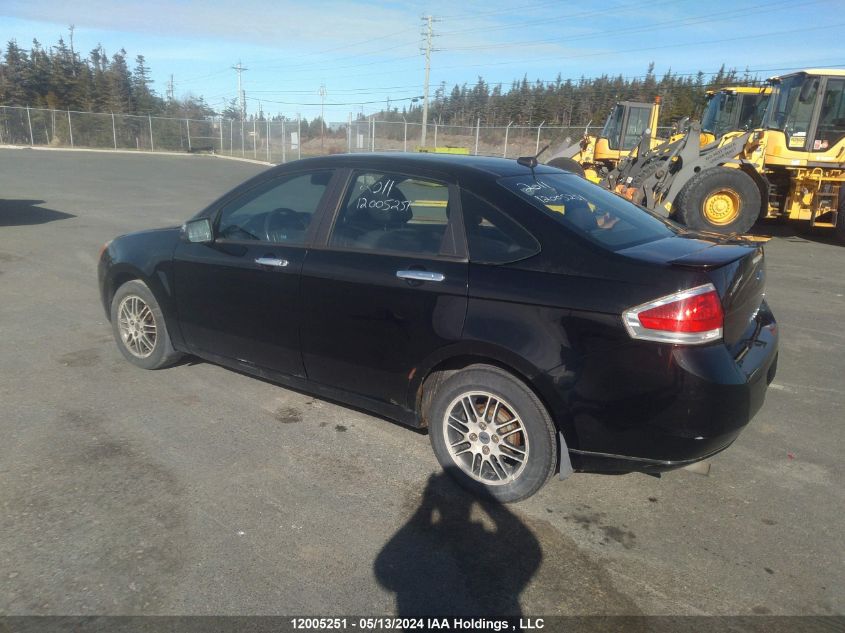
[570,303,778,473]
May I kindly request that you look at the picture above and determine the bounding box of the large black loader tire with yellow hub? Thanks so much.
[672,167,761,235]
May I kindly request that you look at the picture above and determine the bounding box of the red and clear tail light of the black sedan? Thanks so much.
[622,284,725,345]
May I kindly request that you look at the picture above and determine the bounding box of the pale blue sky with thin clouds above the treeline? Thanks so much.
[0,0,845,121]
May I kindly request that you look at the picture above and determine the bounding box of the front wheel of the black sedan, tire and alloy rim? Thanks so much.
[111,279,182,369]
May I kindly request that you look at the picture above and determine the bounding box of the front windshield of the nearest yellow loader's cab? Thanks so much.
[763,74,819,150]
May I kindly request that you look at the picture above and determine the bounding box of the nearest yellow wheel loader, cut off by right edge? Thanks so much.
[605,69,845,242]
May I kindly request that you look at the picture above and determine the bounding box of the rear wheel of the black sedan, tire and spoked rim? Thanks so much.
[426,364,558,503]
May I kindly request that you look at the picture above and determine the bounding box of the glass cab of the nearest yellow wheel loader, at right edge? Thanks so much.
[763,70,845,156]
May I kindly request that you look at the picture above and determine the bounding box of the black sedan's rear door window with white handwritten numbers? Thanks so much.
[329,172,449,255]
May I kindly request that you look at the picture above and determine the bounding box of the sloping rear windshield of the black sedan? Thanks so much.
[499,174,676,251]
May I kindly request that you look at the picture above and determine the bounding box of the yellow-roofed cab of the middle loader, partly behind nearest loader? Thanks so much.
[701,86,771,143]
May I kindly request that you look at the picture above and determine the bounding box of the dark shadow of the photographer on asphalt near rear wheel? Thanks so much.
[374,473,543,617]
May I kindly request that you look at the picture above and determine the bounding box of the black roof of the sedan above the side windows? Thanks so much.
[280,152,558,178]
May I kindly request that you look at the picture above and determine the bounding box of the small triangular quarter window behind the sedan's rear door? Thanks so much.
[461,191,540,264]
